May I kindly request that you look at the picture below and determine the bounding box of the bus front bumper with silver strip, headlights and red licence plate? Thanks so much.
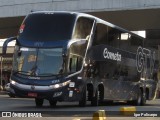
[10,80,80,101]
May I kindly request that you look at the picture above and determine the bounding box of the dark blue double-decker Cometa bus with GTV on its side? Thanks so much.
[3,11,157,107]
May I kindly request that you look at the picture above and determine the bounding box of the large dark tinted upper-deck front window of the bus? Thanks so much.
[19,13,75,40]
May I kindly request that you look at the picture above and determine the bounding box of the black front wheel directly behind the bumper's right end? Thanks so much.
[79,88,87,107]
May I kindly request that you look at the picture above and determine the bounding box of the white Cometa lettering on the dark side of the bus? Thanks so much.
[103,48,121,61]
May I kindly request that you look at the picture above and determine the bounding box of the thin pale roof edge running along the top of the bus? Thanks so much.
[31,11,144,39]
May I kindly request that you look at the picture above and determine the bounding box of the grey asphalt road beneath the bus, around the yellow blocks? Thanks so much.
[0,95,160,120]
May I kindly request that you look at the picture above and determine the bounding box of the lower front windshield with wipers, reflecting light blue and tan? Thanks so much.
[13,46,63,76]
